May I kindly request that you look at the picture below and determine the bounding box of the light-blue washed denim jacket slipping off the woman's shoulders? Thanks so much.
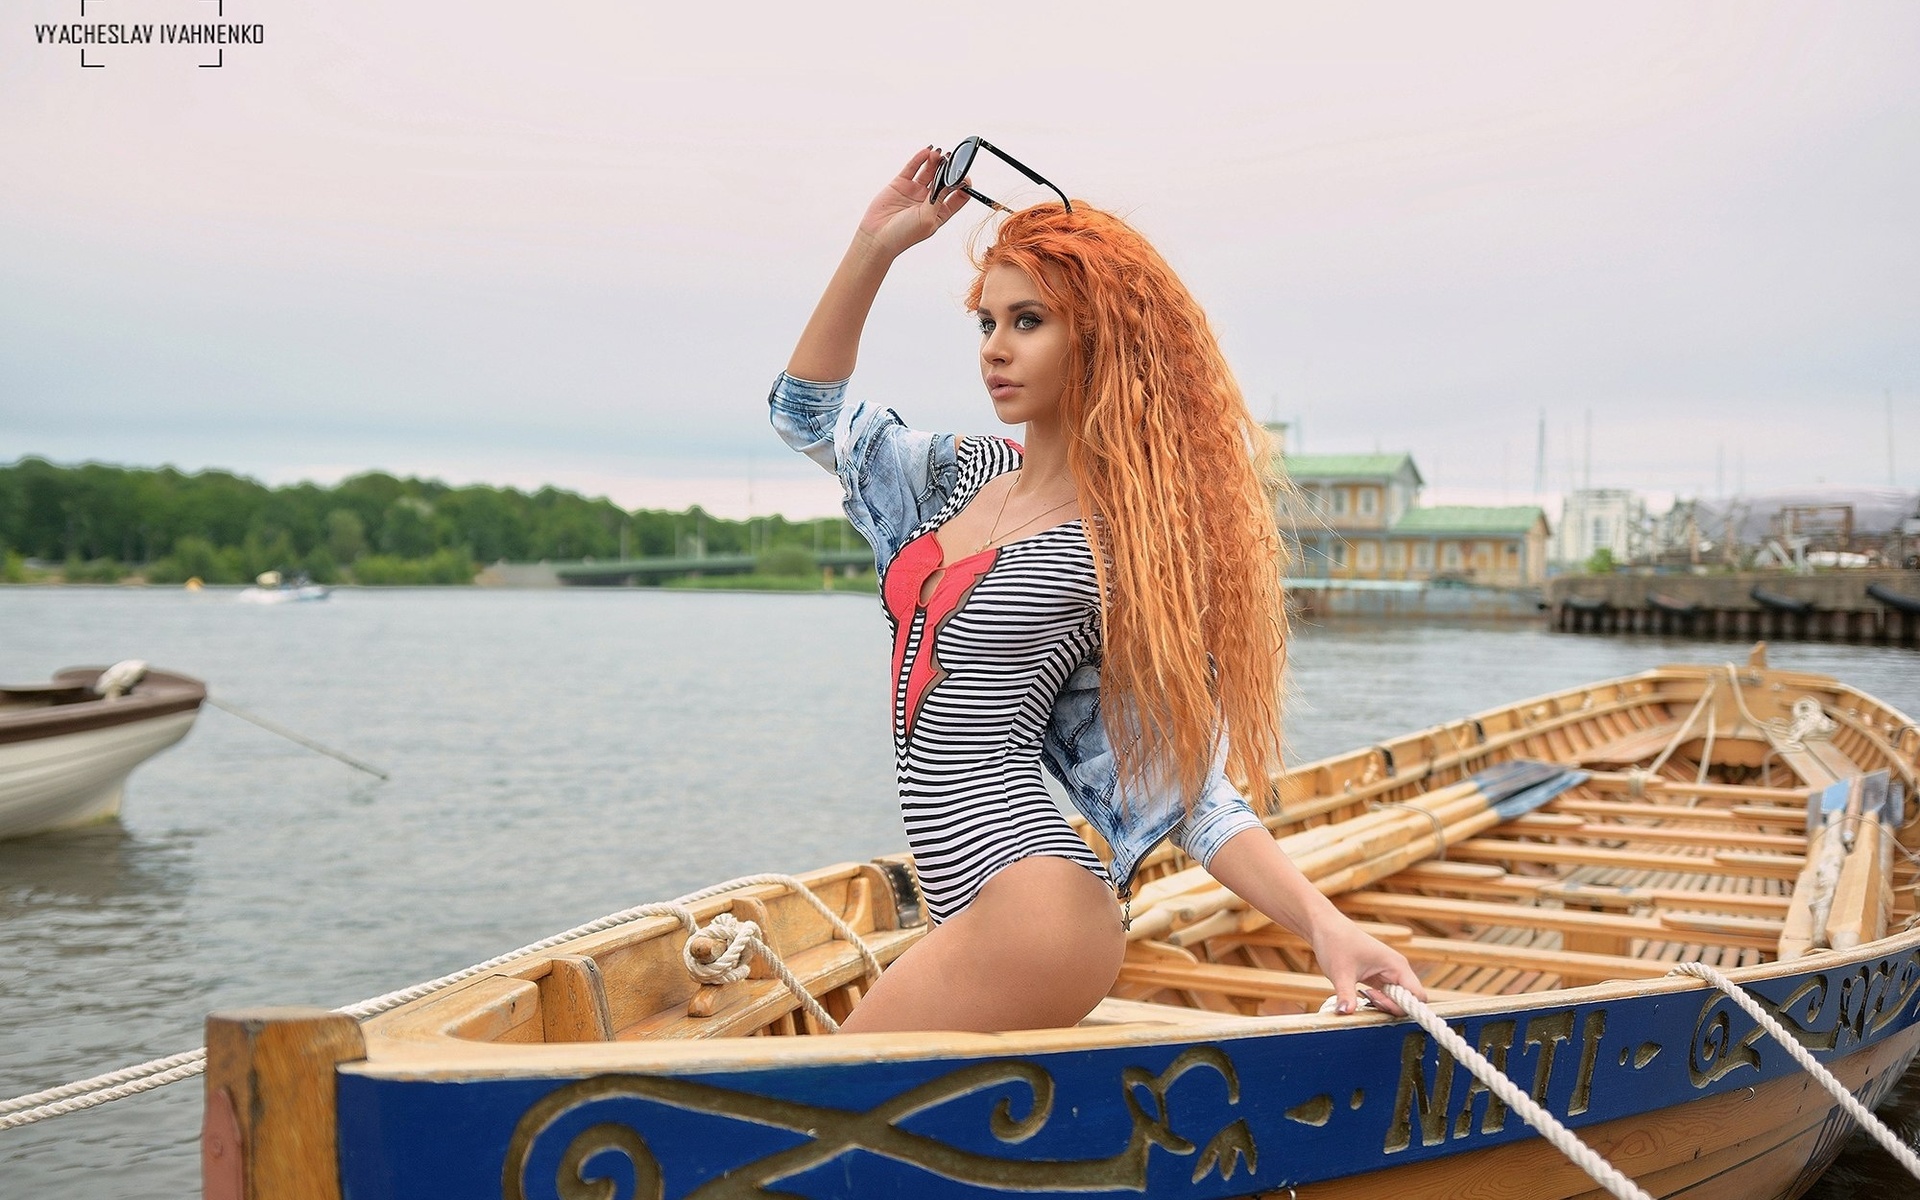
[766,374,1261,897]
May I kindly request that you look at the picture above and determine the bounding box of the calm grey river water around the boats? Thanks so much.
[0,588,1920,1200]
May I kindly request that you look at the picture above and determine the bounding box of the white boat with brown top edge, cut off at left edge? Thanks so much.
[0,660,207,837]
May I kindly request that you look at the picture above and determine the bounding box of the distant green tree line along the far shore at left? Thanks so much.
[0,457,862,584]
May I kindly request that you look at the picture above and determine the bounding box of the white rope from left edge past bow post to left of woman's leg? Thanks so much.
[0,876,879,1131]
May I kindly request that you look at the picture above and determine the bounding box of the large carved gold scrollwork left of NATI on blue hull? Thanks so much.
[501,1046,1258,1200]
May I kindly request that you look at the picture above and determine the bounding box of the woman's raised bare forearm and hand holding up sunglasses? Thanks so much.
[787,146,968,384]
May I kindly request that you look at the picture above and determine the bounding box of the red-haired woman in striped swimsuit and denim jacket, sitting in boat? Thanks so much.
[770,146,1423,1033]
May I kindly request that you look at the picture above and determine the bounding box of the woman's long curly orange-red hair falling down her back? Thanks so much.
[966,202,1286,806]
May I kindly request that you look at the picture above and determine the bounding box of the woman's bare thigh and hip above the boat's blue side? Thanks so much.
[841,854,1127,1033]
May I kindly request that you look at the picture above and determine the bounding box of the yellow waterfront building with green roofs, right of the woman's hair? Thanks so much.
[1283,453,1549,588]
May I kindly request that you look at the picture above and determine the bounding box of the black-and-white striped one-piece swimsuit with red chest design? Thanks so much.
[881,438,1108,924]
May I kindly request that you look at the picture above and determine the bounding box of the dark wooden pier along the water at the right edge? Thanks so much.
[1548,570,1920,647]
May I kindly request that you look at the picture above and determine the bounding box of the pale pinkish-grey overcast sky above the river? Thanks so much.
[0,0,1920,516]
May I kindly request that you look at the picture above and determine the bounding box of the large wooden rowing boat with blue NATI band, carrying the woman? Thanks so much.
[205,657,1920,1200]
